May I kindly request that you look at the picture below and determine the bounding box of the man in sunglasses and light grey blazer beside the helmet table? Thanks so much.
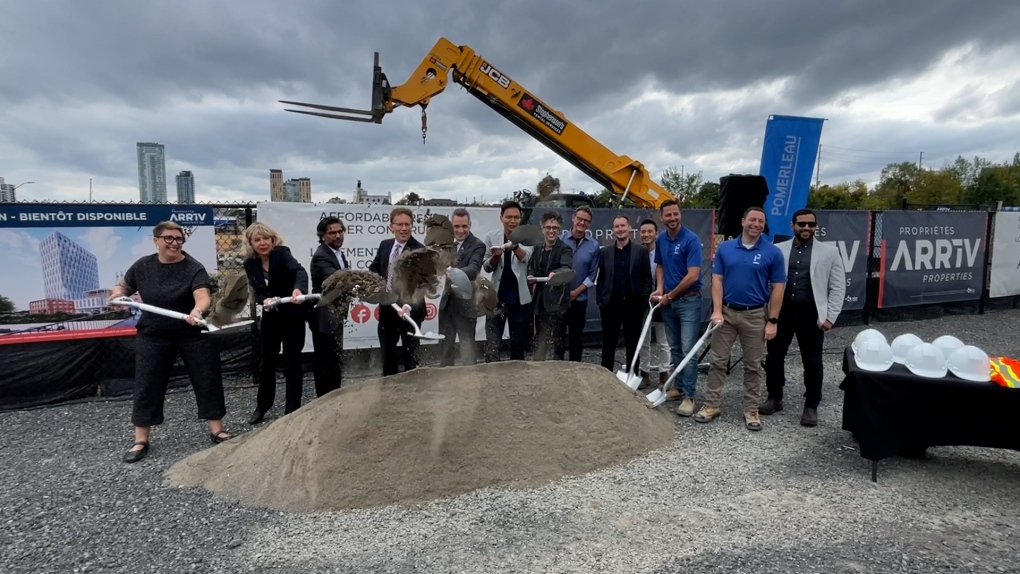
[758,209,847,426]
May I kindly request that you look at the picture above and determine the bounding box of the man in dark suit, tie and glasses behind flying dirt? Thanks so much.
[368,207,425,376]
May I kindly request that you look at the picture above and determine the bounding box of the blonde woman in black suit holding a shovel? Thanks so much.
[245,222,308,424]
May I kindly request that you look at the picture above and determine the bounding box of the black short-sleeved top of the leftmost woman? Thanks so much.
[120,254,212,336]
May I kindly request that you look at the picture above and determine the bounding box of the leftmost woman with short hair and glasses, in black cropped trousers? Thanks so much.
[110,221,232,463]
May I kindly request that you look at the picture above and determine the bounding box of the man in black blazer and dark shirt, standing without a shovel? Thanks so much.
[596,214,652,370]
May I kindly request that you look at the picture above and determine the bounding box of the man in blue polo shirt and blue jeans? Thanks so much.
[652,200,702,417]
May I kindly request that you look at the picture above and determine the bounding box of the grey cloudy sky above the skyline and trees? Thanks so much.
[0,0,1020,206]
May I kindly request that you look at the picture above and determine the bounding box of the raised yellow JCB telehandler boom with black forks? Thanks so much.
[281,38,672,208]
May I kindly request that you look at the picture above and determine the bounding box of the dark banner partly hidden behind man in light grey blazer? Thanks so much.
[815,211,871,311]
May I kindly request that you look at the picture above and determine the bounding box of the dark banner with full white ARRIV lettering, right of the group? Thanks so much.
[878,211,987,308]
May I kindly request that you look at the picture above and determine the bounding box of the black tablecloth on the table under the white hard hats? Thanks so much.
[839,347,1020,461]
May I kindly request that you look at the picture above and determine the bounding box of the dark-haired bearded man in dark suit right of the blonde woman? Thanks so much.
[308,217,350,397]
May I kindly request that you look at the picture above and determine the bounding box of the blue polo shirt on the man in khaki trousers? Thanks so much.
[712,238,786,307]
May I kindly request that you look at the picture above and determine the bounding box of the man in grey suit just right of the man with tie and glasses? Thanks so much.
[440,207,486,367]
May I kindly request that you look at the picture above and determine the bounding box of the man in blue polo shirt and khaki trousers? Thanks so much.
[695,207,786,430]
